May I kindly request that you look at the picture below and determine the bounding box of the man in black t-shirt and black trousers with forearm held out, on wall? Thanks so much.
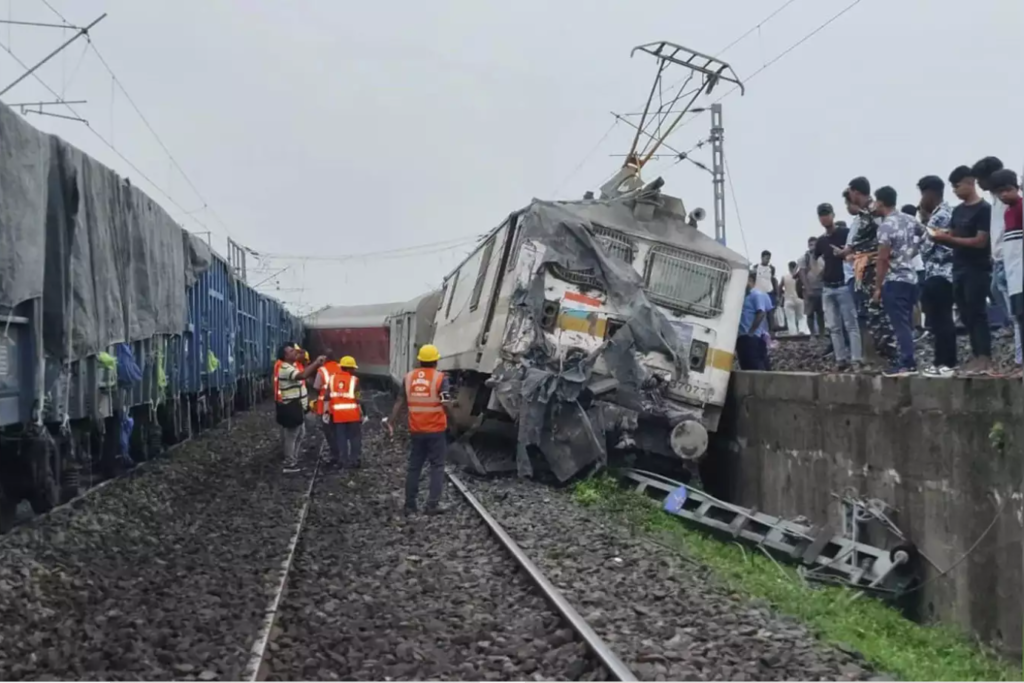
[932,166,992,373]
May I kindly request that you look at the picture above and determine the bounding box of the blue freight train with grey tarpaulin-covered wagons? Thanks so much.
[0,104,302,530]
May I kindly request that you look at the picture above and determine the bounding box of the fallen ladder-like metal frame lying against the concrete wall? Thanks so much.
[620,469,914,596]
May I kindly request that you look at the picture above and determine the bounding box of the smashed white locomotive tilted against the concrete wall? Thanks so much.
[434,181,748,481]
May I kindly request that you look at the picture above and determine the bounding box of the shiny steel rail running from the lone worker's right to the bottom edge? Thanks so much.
[447,472,637,681]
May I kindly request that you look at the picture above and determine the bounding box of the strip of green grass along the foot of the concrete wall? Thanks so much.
[572,476,1024,681]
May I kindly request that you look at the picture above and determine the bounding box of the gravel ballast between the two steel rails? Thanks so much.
[264,423,606,680]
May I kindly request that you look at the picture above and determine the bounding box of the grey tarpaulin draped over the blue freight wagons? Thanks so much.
[0,105,210,359]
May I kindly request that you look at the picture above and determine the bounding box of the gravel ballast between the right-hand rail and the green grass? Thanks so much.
[470,479,871,681]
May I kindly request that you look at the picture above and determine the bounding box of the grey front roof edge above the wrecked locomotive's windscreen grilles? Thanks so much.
[519,194,750,268]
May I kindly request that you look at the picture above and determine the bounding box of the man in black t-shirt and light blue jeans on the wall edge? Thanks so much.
[814,204,864,372]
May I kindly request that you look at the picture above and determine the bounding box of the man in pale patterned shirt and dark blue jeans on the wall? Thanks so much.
[874,185,918,376]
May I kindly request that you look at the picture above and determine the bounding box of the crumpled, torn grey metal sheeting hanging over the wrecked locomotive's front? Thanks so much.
[479,181,746,480]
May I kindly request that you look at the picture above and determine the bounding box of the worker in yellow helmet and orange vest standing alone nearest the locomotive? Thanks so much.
[386,344,449,515]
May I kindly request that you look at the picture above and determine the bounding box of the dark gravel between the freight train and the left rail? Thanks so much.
[0,407,318,680]
